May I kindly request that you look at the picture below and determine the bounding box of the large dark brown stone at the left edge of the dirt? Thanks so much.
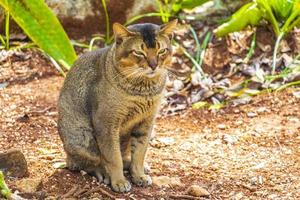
[0,149,28,178]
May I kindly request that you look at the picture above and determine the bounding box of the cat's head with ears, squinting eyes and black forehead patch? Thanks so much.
[113,20,177,79]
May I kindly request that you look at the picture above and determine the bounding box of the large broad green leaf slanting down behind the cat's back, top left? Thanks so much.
[0,0,76,69]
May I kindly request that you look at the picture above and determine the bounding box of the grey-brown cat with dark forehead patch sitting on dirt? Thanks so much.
[58,20,177,192]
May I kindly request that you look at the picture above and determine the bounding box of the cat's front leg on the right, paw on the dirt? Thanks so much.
[130,121,153,187]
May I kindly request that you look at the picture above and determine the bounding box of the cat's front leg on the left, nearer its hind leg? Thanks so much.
[94,117,131,192]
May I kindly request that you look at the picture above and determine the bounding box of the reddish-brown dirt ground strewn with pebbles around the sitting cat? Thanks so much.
[0,55,300,199]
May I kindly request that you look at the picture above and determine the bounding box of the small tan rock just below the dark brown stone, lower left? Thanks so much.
[16,178,42,193]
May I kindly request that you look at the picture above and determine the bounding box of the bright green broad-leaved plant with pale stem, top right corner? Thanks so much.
[214,0,300,74]
